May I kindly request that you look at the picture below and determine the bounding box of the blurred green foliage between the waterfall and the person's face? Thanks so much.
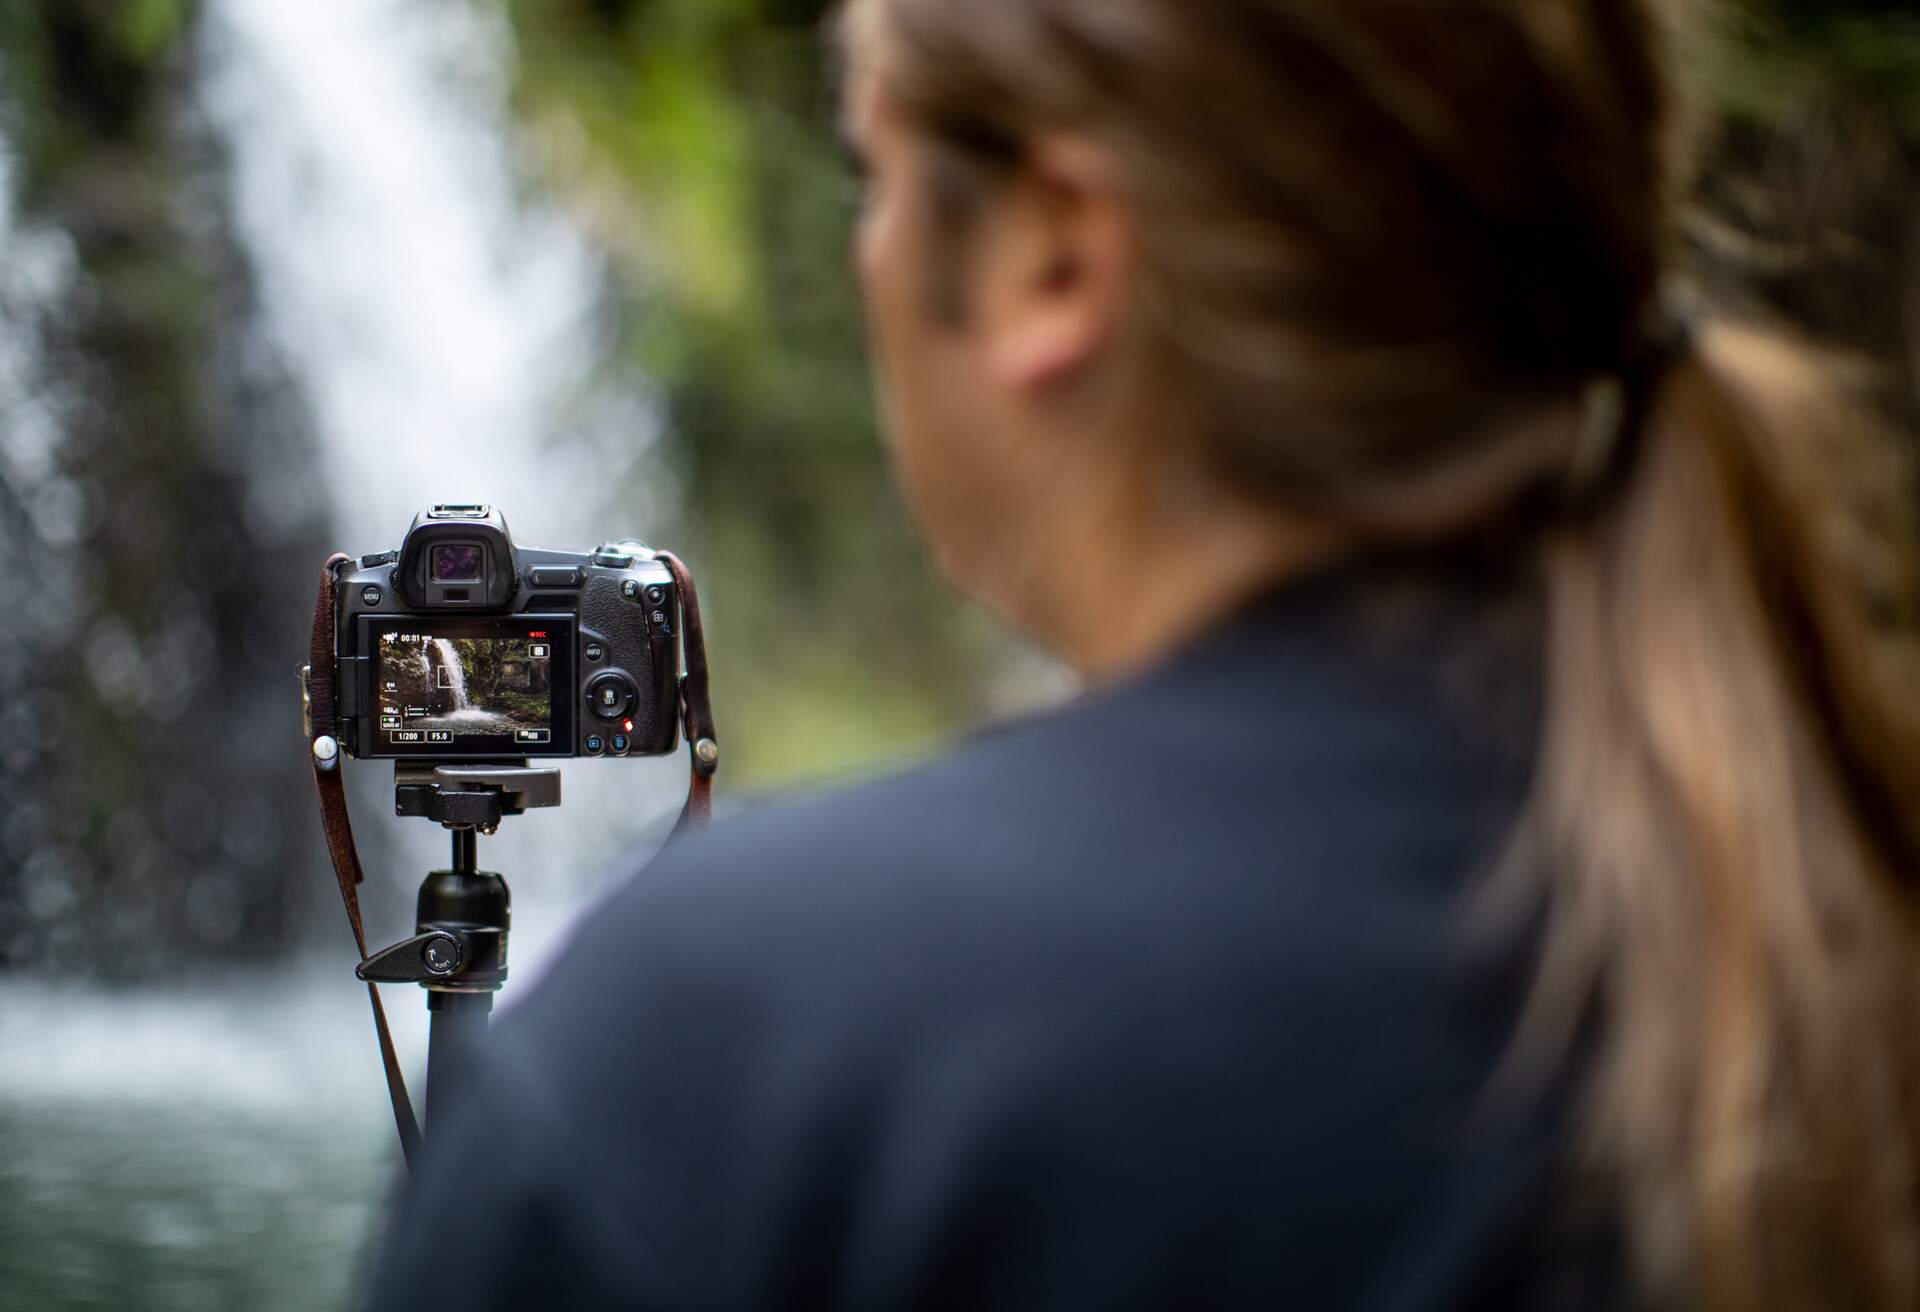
[499,0,993,782]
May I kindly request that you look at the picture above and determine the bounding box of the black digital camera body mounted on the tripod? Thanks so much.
[334,505,680,763]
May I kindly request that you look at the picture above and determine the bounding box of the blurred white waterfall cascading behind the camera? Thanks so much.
[204,0,685,922]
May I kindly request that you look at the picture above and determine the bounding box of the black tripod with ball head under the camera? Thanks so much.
[355,761,561,1126]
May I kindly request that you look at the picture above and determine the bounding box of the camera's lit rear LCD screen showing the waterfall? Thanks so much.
[369,615,574,759]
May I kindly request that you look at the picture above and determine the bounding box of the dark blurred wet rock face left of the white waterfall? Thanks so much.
[0,0,324,976]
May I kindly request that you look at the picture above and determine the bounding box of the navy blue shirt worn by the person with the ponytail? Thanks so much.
[369,565,1597,1312]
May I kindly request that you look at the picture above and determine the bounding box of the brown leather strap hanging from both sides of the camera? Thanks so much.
[305,551,720,1168]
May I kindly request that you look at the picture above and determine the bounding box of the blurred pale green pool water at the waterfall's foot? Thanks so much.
[0,918,587,1312]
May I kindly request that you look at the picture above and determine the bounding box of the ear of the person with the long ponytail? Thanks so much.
[983,138,1137,394]
